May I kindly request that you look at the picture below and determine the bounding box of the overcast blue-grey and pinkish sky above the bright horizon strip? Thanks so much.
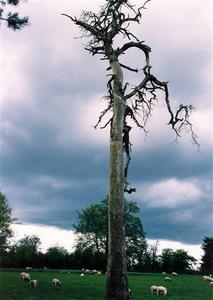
[0,0,213,258]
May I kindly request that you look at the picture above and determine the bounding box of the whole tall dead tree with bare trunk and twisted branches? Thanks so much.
[63,0,196,300]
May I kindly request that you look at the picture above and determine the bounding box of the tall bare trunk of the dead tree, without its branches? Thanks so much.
[105,59,129,300]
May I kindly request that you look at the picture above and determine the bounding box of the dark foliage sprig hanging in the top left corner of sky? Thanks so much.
[0,0,29,30]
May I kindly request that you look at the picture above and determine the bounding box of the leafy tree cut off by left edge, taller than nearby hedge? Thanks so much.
[0,192,15,257]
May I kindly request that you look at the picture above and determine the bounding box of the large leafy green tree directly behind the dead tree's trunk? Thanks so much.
[74,198,147,269]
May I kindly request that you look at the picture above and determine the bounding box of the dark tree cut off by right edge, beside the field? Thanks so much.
[201,236,213,274]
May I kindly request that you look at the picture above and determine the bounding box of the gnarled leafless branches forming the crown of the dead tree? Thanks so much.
[63,0,199,192]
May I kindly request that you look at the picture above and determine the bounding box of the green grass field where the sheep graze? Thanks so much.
[0,270,213,300]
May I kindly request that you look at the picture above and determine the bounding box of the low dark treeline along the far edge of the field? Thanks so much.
[0,236,196,273]
